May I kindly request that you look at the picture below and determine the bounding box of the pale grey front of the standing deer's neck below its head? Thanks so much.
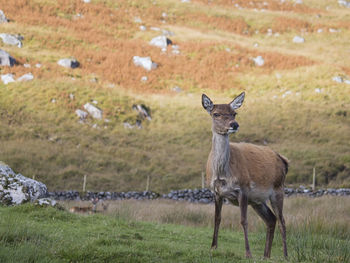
[212,131,230,178]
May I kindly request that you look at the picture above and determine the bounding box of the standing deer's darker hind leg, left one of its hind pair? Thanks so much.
[252,203,276,258]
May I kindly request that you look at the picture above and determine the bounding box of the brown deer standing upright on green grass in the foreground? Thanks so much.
[202,92,289,259]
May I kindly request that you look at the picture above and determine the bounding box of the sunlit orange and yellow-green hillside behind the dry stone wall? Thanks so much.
[0,0,350,192]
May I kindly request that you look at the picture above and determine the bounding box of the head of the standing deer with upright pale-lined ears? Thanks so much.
[202,92,245,135]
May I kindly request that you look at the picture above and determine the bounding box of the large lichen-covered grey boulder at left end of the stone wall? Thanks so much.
[0,162,48,205]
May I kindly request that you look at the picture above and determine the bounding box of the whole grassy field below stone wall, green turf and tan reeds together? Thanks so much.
[0,197,350,262]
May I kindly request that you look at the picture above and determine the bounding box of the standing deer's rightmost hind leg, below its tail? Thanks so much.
[270,190,288,258]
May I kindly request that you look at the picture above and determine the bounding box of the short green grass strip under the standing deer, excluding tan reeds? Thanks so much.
[0,204,350,262]
